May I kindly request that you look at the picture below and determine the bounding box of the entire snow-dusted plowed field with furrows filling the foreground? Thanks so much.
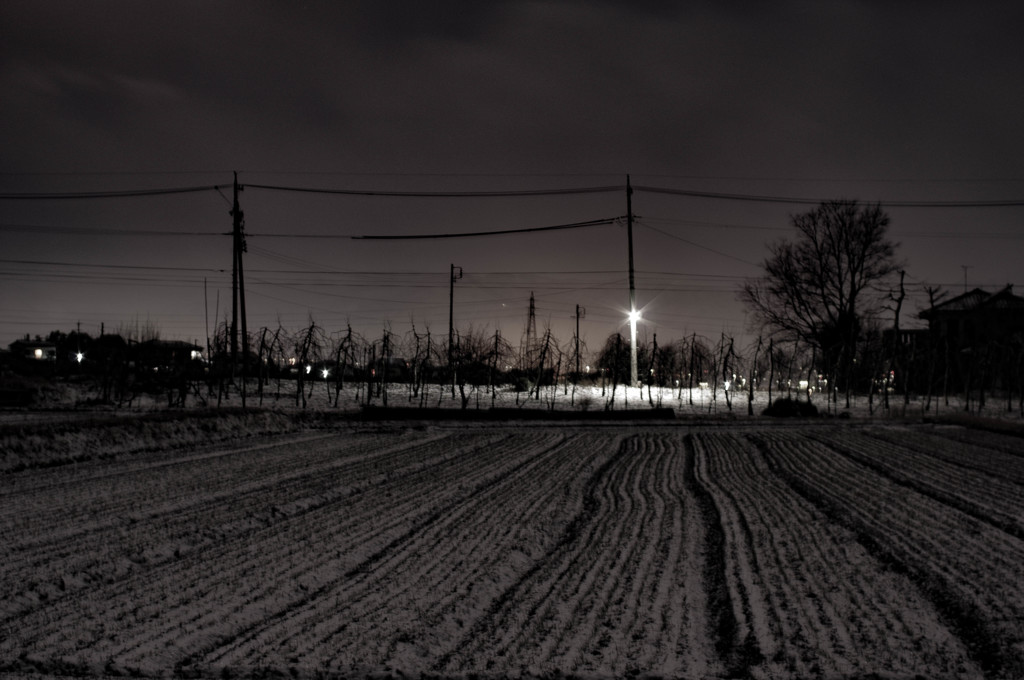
[0,403,1024,679]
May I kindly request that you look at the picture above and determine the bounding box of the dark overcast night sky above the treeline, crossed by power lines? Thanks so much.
[0,0,1024,356]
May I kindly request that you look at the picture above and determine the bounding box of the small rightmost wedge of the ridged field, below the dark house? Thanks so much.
[865,427,1024,486]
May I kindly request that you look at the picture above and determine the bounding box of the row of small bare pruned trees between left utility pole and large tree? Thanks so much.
[197,318,839,414]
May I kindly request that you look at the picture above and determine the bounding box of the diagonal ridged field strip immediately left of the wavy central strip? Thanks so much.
[205,430,593,666]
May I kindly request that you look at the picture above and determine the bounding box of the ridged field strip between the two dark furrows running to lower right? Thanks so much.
[761,432,1024,677]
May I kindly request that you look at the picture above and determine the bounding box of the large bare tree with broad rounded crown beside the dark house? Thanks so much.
[739,200,898,407]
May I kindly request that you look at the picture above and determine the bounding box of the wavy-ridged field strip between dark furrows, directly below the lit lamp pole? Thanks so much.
[443,436,711,675]
